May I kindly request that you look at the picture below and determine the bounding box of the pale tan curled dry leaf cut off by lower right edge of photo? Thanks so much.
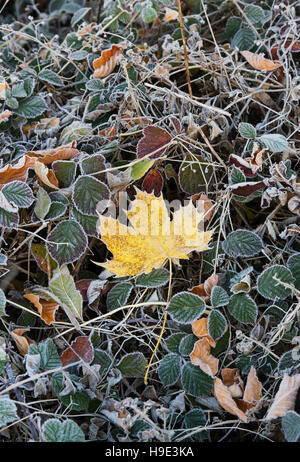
[266,374,300,420]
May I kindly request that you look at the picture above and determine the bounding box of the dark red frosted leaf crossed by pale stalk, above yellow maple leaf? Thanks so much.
[137,125,172,159]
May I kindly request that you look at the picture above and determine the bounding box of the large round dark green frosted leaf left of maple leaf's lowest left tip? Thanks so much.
[47,220,88,265]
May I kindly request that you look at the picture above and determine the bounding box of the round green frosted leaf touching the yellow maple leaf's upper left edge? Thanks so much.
[72,175,110,216]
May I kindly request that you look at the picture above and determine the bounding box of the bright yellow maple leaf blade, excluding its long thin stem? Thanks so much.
[97,189,213,276]
